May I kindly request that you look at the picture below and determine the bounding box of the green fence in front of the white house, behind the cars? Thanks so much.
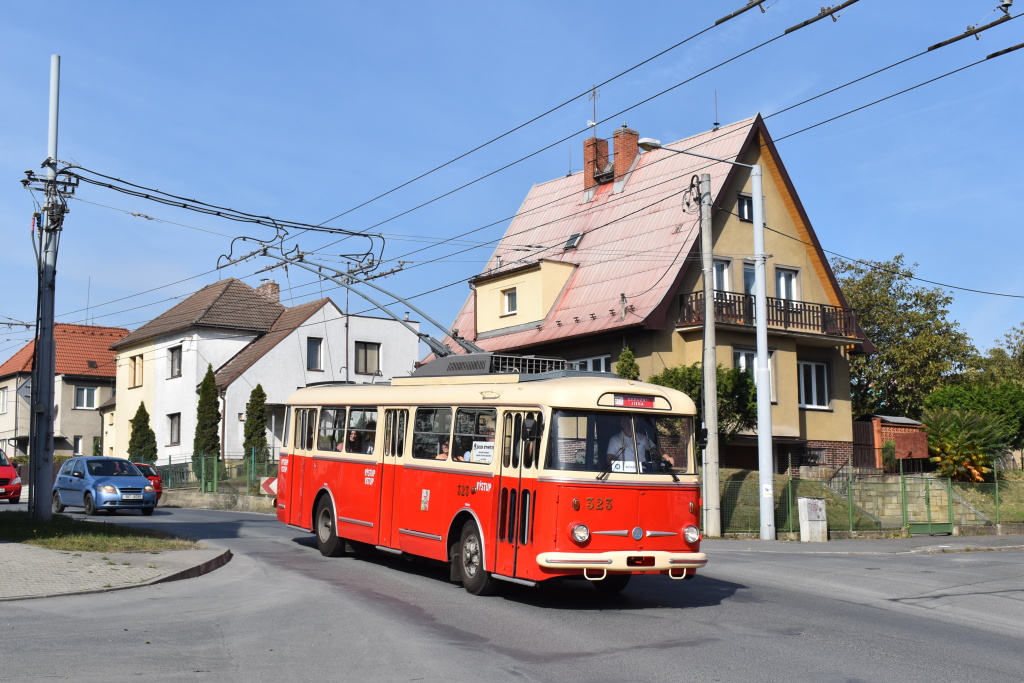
[156,453,278,496]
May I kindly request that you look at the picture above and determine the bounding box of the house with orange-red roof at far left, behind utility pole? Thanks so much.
[0,323,128,457]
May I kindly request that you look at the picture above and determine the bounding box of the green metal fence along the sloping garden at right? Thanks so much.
[721,456,1024,533]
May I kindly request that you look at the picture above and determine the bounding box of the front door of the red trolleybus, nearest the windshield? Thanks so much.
[493,412,540,577]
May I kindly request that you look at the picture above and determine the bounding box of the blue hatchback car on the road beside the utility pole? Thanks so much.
[53,458,157,515]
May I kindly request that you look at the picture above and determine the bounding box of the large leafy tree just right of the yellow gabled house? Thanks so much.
[835,254,975,418]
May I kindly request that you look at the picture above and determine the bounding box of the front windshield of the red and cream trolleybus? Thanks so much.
[546,411,693,474]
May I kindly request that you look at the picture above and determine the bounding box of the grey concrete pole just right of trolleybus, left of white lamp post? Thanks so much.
[700,173,722,538]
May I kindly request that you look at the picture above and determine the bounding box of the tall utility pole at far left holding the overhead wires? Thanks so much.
[29,54,63,520]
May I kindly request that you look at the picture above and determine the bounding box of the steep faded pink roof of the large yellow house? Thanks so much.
[446,118,766,350]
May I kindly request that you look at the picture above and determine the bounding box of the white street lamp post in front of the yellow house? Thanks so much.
[751,164,775,541]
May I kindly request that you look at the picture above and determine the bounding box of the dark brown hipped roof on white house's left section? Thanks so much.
[113,278,285,350]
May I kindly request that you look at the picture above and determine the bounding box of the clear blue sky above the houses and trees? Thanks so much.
[0,0,1024,357]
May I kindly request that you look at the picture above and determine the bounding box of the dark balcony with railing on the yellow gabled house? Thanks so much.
[677,292,857,339]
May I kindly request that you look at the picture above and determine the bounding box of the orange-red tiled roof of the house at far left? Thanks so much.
[0,323,128,378]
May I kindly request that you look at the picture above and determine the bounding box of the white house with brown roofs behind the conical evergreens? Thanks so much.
[111,278,419,464]
